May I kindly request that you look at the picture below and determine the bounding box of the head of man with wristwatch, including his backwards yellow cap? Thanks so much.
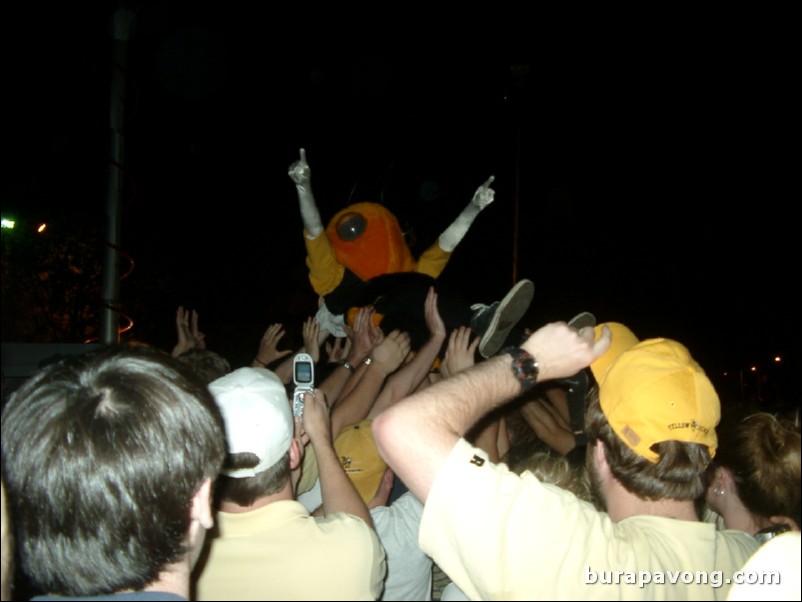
[586,325,720,500]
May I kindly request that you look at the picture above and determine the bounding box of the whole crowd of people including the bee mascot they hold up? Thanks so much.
[2,150,801,600]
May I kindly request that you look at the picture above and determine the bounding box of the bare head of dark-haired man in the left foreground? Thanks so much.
[2,347,225,596]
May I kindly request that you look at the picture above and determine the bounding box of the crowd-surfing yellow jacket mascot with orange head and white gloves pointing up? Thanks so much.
[289,149,534,357]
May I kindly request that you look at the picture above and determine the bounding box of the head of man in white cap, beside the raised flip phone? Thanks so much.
[209,368,294,506]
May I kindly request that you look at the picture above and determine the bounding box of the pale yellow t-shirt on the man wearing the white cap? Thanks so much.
[195,500,387,600]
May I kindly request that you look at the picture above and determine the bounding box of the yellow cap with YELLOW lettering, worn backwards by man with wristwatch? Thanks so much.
[594,333,721,462]
